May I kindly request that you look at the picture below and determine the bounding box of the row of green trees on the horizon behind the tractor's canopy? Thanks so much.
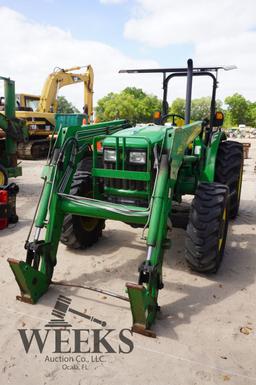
[95,87,256,127]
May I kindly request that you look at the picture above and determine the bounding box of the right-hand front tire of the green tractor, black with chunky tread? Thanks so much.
[185,183,229,273]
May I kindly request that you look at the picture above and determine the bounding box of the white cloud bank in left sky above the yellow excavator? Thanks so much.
[0,7,160,108]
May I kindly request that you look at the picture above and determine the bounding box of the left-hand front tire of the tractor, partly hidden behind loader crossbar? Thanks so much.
[60,171,105,249]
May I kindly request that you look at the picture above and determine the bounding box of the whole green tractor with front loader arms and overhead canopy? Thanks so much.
[8,59,243,336]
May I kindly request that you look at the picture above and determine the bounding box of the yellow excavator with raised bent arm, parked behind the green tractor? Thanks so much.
[12,65,94,159]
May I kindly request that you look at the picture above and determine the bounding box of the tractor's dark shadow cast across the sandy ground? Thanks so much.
[15,201,256,339]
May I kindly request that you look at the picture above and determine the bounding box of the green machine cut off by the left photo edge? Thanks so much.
[0,76,28,185]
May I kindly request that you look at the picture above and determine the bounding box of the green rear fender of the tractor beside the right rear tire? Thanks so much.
[200,131,226,182]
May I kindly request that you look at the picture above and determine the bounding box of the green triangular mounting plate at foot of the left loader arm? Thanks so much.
[7,258,49,304]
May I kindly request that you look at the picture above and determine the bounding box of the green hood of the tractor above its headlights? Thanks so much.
[103,125,170,148]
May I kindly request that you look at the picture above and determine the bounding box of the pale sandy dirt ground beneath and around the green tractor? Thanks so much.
[0,140,256,385]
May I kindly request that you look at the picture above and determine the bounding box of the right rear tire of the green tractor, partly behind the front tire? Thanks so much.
[215,140,243,219]
